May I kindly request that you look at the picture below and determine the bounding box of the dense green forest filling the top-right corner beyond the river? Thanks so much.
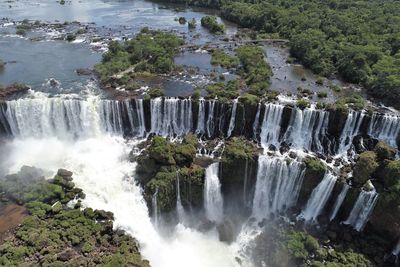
[163,0,400,107]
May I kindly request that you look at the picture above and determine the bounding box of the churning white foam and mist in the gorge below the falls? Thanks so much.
[2,134,244,267]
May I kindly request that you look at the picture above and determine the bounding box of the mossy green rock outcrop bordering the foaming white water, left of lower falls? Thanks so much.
[137,134,204,212]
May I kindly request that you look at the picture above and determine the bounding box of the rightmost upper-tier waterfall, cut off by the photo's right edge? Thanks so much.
[368,114,400,147]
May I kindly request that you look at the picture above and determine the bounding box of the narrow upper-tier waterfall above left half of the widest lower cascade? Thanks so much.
[260,104,283,148]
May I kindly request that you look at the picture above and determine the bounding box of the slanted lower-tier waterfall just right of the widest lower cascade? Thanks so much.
[299,172,337,222]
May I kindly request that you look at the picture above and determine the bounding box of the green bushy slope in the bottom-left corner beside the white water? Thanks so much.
[0,167,149,267]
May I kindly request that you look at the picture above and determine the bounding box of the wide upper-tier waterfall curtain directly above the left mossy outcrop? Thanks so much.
[150,97,193,137]
